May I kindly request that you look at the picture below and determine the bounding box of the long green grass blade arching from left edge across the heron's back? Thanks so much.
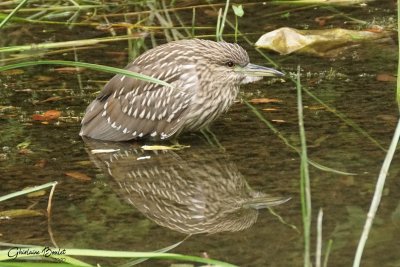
[0,60,172,88]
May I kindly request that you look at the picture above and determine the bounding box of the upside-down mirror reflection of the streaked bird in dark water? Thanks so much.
[84,138,287,234]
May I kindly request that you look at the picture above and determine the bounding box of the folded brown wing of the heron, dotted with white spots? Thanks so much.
[80,64,198,141]
